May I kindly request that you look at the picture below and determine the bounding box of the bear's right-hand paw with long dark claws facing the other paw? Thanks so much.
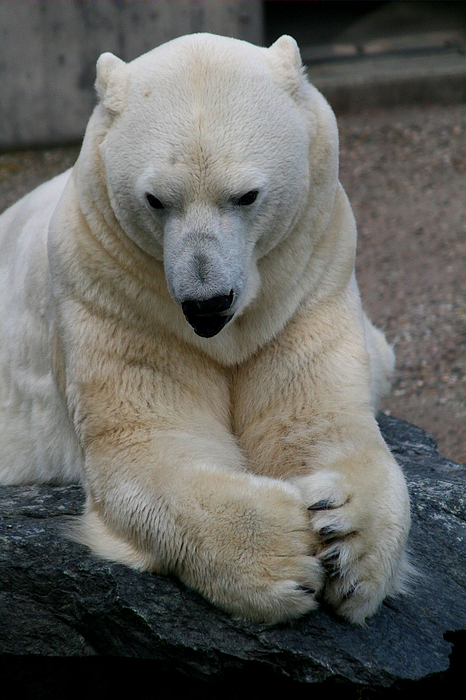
[294,471,410,623]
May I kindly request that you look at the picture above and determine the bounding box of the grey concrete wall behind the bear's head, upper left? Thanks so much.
[0,0,263,149]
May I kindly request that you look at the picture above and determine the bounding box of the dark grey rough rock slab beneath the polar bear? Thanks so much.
[0,414,466,698]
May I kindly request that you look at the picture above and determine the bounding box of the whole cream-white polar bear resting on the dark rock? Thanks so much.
[0,34,410,623]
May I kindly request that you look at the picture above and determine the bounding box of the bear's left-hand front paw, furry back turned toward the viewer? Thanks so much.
[177,476,324,624]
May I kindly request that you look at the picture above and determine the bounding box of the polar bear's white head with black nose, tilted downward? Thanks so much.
[87,34,331,337]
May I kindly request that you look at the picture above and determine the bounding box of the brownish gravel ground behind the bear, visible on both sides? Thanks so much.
[0,105,466,464]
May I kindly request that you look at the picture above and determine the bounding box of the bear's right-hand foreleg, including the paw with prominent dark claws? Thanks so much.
[233,296,410,622]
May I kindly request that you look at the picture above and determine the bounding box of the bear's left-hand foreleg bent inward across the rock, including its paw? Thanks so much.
[69,360,323,623]
